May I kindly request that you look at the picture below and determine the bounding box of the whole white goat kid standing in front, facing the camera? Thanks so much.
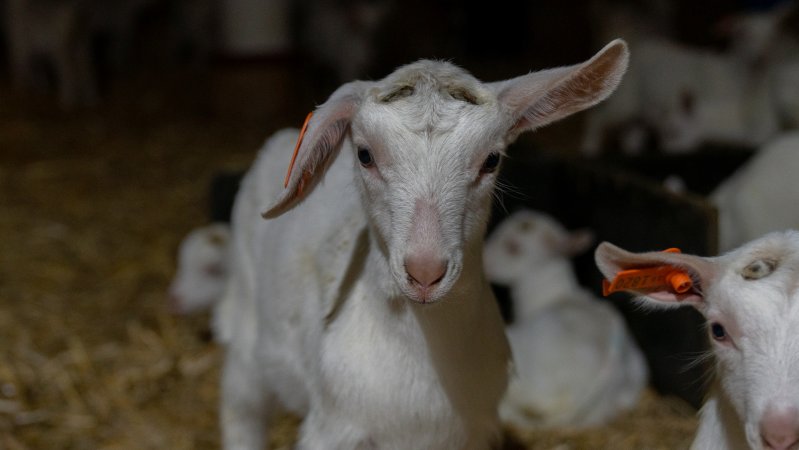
[215,41,628,449]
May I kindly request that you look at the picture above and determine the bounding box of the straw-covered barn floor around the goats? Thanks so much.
[0,66,696,450]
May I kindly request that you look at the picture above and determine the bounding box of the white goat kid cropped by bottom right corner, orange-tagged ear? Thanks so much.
[596,231,799,450]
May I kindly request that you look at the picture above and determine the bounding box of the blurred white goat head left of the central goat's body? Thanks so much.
[169,223,230,314]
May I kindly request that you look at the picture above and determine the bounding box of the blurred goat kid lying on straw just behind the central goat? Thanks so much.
[484,210,648,427]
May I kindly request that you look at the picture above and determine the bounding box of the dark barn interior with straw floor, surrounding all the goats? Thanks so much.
[0,0,796,450]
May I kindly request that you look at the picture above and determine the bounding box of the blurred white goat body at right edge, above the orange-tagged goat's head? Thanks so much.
[710,132,799,251]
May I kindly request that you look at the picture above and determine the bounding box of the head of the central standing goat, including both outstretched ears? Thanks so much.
[264,41,628,303]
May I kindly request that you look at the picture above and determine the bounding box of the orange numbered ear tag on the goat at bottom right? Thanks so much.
[602,248,693,297]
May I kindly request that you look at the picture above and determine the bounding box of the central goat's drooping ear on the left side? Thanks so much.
[262,81,368,219]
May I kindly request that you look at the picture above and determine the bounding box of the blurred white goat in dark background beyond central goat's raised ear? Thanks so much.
[582,40,780,155]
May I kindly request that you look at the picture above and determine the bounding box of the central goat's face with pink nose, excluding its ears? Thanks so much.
[351,71,506,303]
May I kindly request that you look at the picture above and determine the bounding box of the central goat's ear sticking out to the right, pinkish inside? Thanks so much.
[491,39,629,141]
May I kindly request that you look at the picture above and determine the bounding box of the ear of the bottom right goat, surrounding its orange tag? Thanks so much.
[594,242,717,307]
